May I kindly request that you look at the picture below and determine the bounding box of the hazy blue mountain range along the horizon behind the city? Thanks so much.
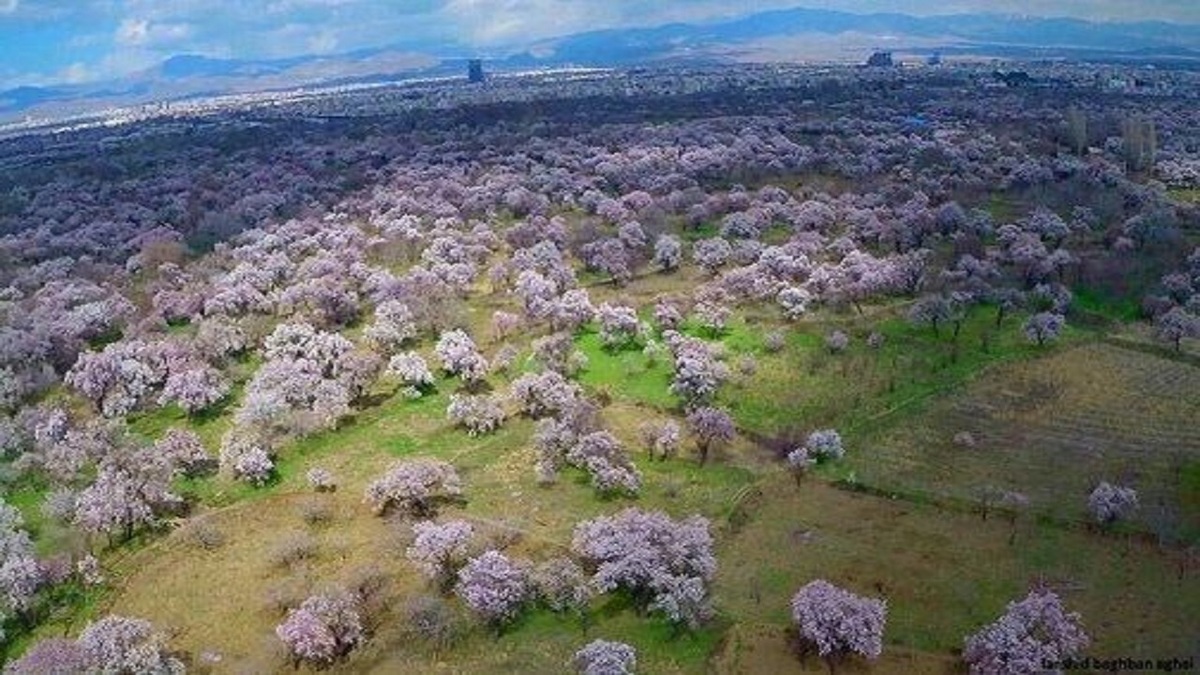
[0,8,1200,120]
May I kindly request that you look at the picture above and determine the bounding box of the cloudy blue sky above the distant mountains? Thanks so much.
[0,0,1200,88]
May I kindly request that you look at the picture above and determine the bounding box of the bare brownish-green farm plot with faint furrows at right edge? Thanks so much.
[847,344,1200,534]
